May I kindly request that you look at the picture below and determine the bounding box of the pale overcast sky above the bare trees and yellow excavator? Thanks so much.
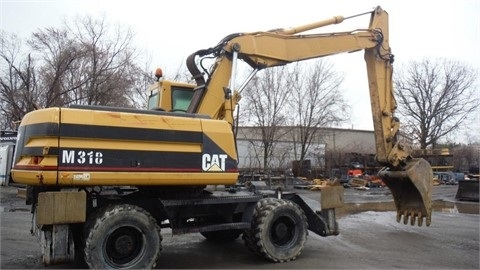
[0,0,480,141]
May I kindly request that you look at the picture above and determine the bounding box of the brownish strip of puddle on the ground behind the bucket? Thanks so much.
[336,201,480,217]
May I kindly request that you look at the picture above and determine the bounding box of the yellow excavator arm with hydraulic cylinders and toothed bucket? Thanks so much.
[187,7,433,226]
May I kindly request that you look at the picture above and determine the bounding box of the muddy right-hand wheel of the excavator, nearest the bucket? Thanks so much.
[243,198,308,262]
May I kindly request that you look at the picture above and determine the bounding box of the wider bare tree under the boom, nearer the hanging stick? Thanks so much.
[288,59,349,170]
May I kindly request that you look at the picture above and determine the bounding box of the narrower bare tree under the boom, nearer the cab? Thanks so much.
[244,66,290,171]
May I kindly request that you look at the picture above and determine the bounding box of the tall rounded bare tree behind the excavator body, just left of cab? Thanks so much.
[66,16,141,106]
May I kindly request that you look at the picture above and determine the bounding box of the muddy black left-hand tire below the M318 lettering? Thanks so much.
[85,204,162,269]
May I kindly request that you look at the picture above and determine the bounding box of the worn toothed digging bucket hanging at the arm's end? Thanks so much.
[378,158,433,226]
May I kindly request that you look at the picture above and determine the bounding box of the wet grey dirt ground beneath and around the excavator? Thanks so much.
[0,186,480,269]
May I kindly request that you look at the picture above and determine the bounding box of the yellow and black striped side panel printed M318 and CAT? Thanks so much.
[10,106,238,185]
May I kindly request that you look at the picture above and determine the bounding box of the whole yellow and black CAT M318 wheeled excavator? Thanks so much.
[12,7,433,268]
